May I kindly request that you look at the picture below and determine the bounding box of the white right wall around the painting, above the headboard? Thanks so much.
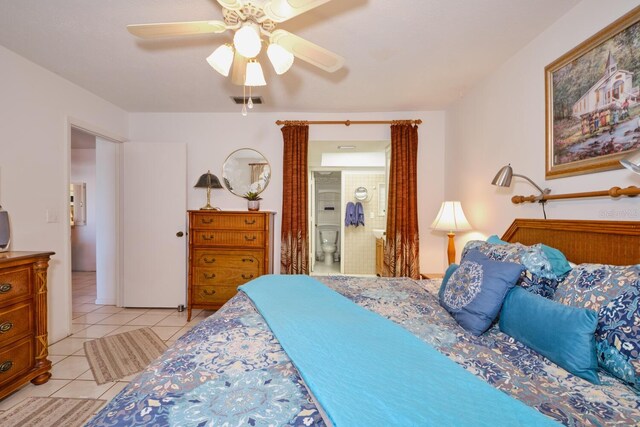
[445,0,640,253]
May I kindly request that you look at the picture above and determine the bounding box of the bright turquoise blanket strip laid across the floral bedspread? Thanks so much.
[240,276,557,427]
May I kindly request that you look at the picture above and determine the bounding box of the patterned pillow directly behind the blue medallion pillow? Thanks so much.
[462,240,561,298]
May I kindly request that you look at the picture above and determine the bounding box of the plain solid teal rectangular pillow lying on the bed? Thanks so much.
[500,286,600,384]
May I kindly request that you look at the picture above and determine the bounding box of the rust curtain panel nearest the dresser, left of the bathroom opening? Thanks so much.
[280,122,309,274]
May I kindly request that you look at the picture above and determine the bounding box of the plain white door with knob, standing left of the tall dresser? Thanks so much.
[122,143,187,307]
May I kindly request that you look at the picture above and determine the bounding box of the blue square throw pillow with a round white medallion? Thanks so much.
[440,250,524,336]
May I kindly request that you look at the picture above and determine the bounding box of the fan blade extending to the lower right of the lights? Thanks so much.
[270,30,344,73]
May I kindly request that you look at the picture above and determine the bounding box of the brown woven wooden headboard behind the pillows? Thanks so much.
[502,219,640,265]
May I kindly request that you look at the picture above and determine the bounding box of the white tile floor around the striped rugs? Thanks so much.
[0,272,212,420]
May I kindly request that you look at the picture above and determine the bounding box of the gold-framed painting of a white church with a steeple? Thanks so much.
[545,7,640,179]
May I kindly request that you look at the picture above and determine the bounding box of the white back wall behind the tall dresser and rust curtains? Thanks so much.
[129,111,446,272]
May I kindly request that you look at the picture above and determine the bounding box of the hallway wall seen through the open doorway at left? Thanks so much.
[71,149,96,271]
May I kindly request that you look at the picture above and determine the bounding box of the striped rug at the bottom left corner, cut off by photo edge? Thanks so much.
[0,397,105,427]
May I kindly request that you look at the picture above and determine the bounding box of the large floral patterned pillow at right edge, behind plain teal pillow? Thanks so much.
[553,264,640,390]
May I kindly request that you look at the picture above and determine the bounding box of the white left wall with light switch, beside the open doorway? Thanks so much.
[0,46,127,342]
